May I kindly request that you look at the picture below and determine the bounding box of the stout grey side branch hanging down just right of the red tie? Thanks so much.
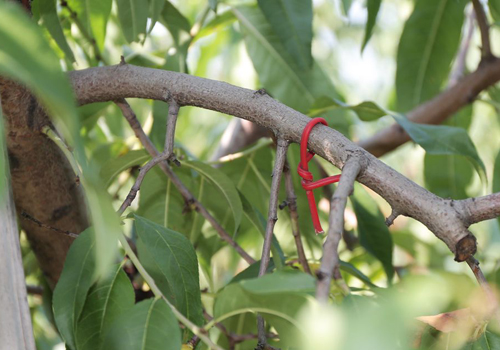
[316,157,361,302]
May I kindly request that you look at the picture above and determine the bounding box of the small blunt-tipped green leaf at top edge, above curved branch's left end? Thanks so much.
[116,0,148,43]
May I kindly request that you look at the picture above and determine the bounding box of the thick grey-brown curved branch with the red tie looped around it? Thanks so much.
[69,64,476,261]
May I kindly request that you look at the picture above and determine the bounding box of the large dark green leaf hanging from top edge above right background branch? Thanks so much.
[396,0,468,111]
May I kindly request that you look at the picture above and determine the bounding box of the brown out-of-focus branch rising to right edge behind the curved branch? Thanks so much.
[358,57,500,157]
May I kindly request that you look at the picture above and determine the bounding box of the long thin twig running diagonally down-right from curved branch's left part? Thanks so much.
[115,99,255,265]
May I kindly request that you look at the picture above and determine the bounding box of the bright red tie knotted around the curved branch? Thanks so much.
[297,118,340,234]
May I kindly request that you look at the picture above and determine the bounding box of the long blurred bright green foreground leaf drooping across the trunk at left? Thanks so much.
[0,2,121,273]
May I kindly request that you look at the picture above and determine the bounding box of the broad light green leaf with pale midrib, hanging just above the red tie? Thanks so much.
[232,6,339,112]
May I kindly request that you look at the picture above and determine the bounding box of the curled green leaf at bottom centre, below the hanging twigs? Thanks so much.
[214,270,315,348]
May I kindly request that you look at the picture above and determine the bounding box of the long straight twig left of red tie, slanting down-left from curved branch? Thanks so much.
[257,138,288,346]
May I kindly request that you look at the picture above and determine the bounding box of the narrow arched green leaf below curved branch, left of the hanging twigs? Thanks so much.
[186,161,243,232]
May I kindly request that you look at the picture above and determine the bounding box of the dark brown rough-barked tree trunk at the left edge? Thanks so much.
[0,77,88,287]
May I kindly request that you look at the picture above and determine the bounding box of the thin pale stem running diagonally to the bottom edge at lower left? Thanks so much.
[119,235,223,350]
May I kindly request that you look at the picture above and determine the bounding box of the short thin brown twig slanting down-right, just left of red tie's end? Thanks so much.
[280,160,312,275]
